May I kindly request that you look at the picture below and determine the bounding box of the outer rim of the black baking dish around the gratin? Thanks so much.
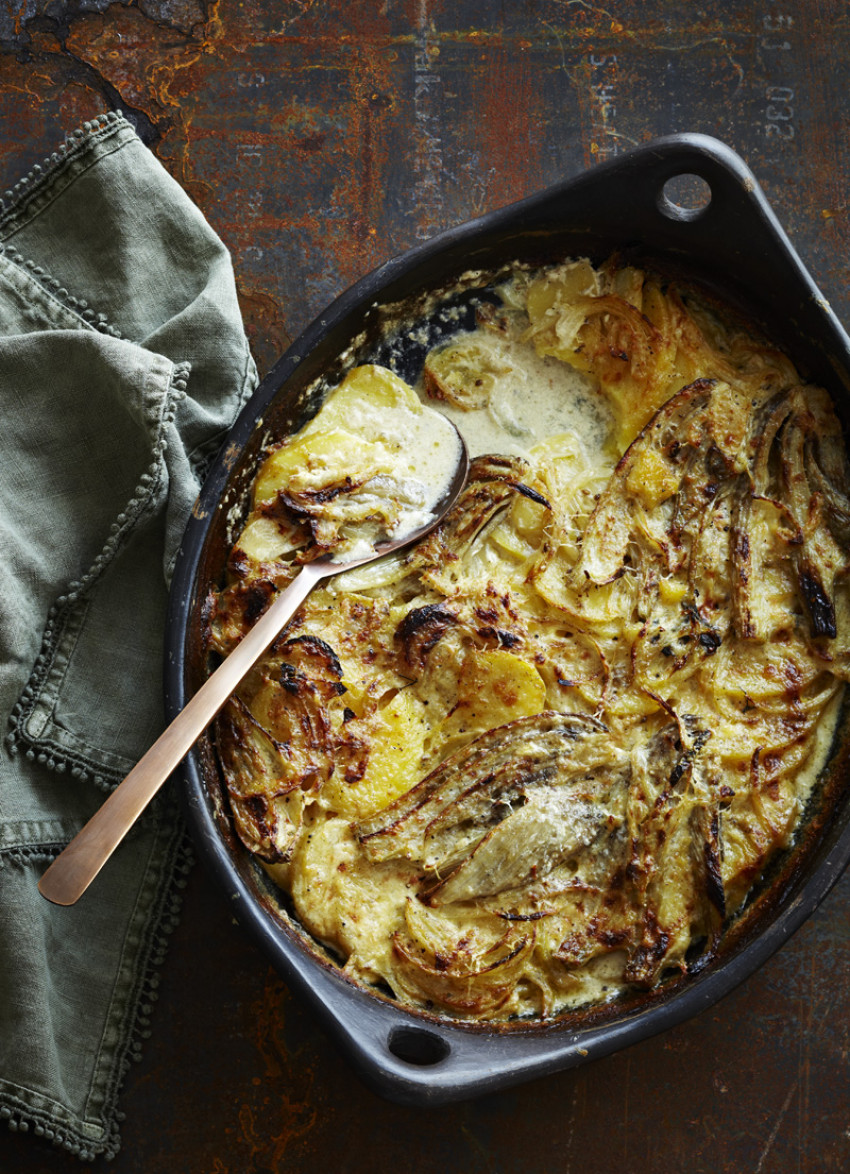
[166,134,850,1104]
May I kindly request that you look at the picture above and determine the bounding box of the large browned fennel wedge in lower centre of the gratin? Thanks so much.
[357,713,628,903]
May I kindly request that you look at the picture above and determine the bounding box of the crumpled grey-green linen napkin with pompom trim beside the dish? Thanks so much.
[0,114,256,1159]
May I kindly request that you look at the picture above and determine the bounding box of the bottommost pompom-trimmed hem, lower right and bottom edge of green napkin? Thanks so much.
[0,826,195,1161]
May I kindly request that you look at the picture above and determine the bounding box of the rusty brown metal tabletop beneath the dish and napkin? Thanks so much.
[0,0,850,1174]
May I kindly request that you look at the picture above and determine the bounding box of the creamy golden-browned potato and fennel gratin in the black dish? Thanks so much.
[208,261,850,1020]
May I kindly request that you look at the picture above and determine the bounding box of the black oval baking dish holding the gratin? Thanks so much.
[166,135,850,1104]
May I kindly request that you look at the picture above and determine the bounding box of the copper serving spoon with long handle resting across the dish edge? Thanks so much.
[39,432,470,905]
